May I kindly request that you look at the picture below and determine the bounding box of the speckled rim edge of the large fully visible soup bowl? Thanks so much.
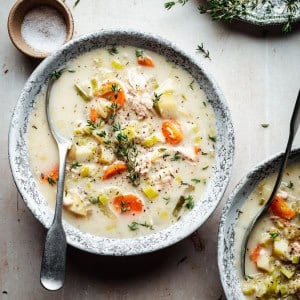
[9,30,234,256]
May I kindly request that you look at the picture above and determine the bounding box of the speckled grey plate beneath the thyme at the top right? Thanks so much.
[240,0,300,25]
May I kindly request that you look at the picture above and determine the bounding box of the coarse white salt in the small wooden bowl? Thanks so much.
[21,6,67,53]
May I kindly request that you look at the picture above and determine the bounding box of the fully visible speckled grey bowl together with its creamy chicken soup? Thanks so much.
[10,32,233,255]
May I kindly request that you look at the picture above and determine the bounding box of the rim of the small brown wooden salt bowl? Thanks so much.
[7,0,74,59]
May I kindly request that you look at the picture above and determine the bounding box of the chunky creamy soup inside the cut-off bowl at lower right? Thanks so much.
[236,163,300,299]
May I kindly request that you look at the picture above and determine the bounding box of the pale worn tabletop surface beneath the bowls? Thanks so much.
[0,0,300,300]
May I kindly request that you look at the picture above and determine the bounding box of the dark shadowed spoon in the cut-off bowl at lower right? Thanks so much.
[241,90,300,279]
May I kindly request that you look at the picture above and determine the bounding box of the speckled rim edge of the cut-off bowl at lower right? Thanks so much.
[218,145,300,299]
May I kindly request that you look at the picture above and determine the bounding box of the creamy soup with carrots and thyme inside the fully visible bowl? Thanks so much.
[28,46,217,238]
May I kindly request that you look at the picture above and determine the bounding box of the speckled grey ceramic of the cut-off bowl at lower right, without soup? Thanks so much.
[218,148,300,300]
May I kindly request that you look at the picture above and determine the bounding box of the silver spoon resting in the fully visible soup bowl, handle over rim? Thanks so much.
[40,72,72,291]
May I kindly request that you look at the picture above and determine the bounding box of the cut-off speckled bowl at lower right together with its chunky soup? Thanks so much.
[219,150,300,299]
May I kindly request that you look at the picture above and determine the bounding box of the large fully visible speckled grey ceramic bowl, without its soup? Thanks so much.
[9,31,234,255]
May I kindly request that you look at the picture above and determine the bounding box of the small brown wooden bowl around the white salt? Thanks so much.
[7,0,74,59]
